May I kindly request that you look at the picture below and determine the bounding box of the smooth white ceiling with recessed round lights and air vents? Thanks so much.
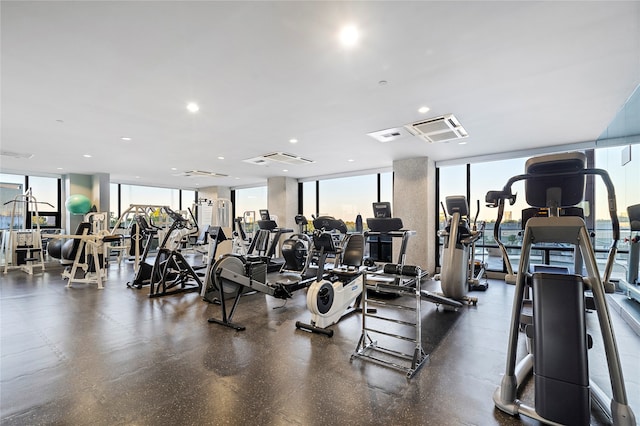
[0,1,640,188]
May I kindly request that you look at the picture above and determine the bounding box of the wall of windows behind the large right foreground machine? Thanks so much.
[438,145,640,276]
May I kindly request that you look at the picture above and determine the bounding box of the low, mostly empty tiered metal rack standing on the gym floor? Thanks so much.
[351,265,429,379]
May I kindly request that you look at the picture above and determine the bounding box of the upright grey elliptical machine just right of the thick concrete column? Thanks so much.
[434,195,488,305]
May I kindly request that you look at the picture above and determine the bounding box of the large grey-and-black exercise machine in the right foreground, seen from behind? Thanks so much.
[486,152,636,425]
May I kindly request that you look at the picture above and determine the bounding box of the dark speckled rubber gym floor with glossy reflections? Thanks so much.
[0,264,640,426]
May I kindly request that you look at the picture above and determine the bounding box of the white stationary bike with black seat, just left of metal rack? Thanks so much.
[296,225,364,337]
